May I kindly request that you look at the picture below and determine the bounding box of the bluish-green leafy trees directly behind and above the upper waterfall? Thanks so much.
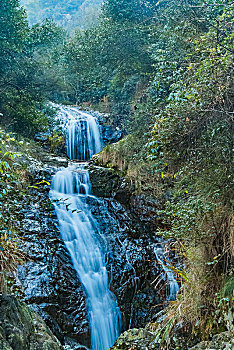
[62,18,154,119]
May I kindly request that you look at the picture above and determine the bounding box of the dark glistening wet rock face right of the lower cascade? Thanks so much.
[85,197,162,330]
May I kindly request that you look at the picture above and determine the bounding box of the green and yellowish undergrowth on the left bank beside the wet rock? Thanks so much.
[0,129,48,295]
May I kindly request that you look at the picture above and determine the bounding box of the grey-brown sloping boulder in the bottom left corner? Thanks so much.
[0,295,63,350]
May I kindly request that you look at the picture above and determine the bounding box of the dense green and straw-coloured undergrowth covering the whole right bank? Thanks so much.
[95,1,234,349]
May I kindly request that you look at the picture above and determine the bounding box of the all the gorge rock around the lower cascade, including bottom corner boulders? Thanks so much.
[0,106,231,350]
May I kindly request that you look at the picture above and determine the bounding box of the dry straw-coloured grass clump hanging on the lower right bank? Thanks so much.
[151,208,234,349]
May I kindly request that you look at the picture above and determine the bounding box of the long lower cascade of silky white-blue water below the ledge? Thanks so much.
[50,165,121,350]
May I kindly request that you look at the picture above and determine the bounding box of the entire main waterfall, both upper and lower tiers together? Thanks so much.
[50,107,121,350]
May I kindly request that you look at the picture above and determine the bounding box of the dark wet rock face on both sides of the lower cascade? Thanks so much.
[0,106,176,350]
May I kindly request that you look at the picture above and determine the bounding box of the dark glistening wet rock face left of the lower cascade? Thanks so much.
[18,164,90,346]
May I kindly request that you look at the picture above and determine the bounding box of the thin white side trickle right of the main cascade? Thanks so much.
[154,245,180,301]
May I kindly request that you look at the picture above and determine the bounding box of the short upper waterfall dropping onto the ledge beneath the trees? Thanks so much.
[57,106,103,161]
